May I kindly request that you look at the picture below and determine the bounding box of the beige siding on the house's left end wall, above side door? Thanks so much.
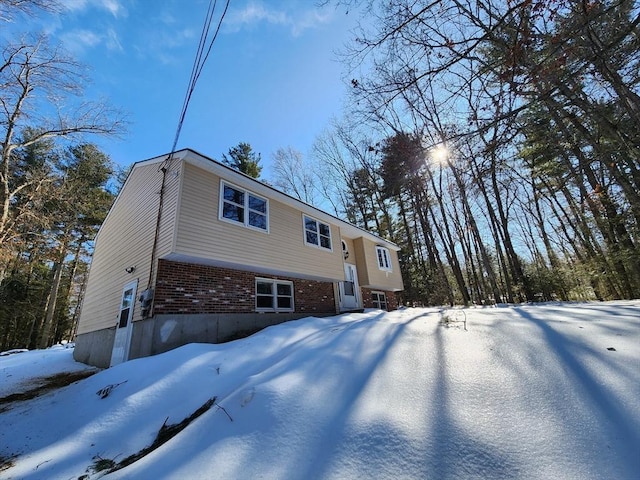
[78,162,180,334]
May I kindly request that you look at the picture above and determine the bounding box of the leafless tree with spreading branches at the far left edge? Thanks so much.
[0,35,124,249]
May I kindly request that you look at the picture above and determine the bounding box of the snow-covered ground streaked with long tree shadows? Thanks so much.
[0,301,640,480]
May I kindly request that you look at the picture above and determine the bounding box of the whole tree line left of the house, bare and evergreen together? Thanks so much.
[0,0,124,351]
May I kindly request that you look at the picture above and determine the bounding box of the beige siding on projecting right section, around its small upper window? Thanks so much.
[353,237,403,291]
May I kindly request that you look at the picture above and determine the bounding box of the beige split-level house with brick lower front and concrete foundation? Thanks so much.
[74,149,403,367]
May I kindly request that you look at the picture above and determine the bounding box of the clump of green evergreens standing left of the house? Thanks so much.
[0,142,114,350]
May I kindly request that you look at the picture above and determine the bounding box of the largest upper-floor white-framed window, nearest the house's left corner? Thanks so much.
[220,182,269,232]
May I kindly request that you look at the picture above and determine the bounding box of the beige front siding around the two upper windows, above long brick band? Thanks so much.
[175,164,344,281]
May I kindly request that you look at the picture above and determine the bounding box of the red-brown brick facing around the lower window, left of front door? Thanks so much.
[153,260,336,314]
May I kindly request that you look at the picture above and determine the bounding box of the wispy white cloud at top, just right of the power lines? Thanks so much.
[224,1,330,36]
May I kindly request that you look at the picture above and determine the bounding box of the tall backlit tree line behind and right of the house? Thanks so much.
[276,0,640,305]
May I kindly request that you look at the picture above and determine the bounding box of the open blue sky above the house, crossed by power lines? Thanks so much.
[12,0,357,174]
